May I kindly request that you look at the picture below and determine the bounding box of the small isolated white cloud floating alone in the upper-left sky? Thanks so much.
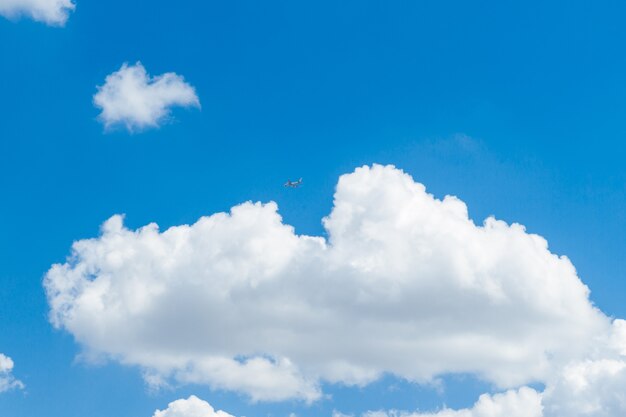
[92,62,200,131]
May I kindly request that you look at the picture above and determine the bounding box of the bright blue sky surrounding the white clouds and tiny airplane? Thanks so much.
[0,0,626,417]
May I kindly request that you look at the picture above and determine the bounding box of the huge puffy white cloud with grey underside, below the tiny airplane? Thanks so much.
[45,165,621,402]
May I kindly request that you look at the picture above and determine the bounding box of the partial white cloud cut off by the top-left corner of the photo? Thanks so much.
[0,0,75,26]
